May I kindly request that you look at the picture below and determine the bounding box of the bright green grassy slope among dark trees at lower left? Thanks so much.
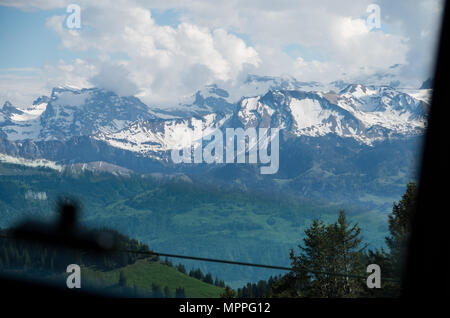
[81,260,224,298]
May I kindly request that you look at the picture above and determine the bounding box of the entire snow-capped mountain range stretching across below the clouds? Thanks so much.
[0,77,431,165]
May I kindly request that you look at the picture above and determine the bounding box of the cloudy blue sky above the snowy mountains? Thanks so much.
[0,0,442,107]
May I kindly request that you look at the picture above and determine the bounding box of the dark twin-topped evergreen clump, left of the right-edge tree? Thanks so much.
[284,210,365,297]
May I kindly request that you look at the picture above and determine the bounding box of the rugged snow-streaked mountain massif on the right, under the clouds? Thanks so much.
[237,84,427,144]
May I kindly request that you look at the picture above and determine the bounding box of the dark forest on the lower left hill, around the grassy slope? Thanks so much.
[0,229,225,298]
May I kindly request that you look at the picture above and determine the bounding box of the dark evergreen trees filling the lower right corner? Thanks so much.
[227,182,417,298]
